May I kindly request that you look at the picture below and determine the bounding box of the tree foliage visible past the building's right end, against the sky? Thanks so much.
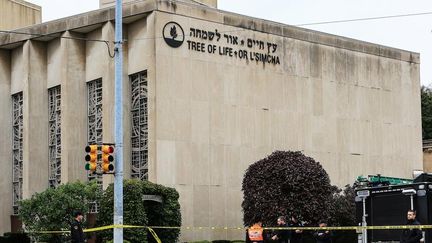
[420,86,432,140]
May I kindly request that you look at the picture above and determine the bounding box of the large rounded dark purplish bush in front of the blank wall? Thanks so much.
[242,151,335,226]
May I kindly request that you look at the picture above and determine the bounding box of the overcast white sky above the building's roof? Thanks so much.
[27,0,432,86]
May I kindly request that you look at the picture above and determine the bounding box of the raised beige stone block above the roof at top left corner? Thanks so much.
[0,0,42,30]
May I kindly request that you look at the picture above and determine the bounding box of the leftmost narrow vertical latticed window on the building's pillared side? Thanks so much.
[12,92,23,215]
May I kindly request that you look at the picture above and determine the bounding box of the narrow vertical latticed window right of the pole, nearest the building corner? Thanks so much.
[129,71,148,180]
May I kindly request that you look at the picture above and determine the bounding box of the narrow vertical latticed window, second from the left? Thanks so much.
[48,86,61,188]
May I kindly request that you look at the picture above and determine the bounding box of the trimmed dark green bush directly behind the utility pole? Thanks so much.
[98,180,181,243]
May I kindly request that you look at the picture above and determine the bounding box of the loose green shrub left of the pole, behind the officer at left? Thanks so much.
[19,182,101,242]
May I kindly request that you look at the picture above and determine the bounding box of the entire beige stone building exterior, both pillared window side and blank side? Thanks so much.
[0,0,423,241]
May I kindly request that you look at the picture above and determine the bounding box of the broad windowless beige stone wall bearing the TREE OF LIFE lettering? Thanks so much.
[150,6,422,240]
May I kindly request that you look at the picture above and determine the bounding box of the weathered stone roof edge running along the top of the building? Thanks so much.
[0,0,420,64]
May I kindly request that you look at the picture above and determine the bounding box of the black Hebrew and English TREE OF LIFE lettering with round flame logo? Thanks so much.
[163,22,280,65]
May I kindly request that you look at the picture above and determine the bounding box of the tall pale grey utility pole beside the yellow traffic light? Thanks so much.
[114,0,123,243]
